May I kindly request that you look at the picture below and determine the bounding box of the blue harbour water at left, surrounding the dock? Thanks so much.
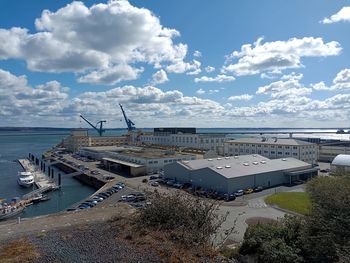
[0,132,94,220]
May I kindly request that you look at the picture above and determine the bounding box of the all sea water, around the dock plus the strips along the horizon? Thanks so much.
[0,128,350,217]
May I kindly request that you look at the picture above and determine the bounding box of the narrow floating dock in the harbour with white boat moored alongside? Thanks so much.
[18,159,59,200]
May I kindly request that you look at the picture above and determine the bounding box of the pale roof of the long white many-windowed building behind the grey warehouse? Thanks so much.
[226,137,315,146]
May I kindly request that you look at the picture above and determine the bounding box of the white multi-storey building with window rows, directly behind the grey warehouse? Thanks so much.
[224,137,318,164]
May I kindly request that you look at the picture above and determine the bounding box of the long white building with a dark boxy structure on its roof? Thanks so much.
[134,128,226,155]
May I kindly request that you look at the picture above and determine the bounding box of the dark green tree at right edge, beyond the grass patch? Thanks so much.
[303,176,350,262]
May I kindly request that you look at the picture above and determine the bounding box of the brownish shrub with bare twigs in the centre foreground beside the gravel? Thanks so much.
[134,191,233,246]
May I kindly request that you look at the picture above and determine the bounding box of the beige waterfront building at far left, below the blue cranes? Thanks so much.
[62,129,128,152]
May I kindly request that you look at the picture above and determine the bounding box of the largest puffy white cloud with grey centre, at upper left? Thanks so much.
[0,1,191,84]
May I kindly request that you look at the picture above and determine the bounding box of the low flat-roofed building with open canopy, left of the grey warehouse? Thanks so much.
[79,146,196,176]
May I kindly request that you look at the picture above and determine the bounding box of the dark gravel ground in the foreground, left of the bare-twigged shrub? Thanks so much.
[28,224,163,263]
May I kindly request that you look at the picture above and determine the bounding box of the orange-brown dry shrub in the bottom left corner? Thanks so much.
[0,239,39,263]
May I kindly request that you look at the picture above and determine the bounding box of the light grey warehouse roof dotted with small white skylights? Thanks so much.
[177,154,311,178]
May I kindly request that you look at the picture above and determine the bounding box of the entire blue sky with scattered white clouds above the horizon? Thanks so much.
[0,0,350,128]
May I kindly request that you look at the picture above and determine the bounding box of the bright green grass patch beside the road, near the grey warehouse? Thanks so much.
[265,192,311,215]
